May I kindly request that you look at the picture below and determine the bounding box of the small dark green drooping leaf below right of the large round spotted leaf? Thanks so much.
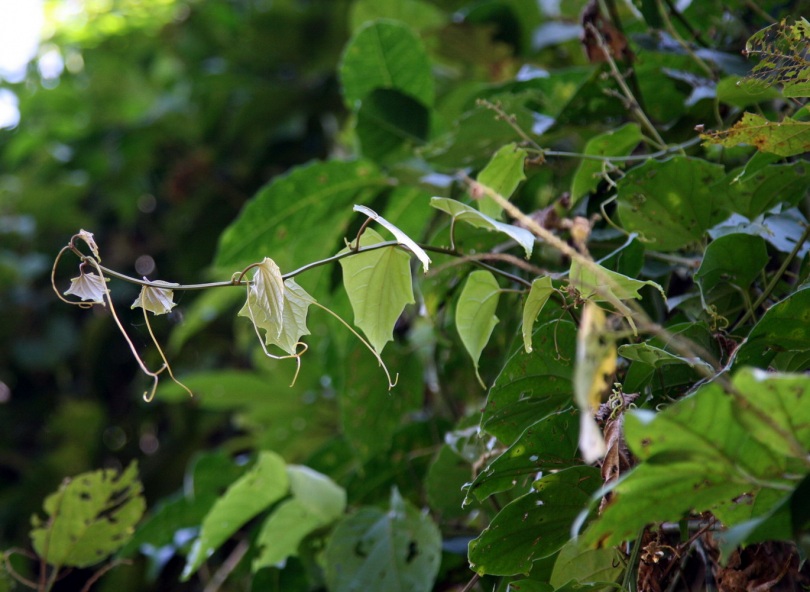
[695,234,768,297]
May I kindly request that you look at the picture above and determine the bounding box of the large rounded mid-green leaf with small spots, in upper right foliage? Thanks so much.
[617,156,727,251]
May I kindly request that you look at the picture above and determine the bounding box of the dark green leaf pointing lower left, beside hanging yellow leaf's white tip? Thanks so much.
[467,411,582,501]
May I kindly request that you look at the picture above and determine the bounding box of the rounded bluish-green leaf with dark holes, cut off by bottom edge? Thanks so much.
[324,490,442,592]
